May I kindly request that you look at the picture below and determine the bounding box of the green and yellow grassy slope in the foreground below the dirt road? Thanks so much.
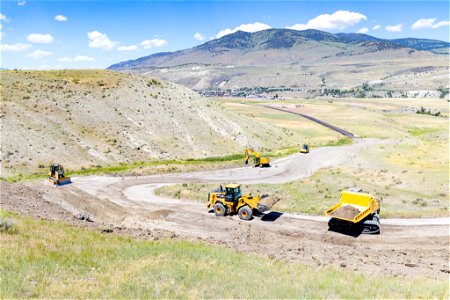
[0,213,448,298]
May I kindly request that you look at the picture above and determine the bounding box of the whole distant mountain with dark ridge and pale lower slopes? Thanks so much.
[109,29,449,97]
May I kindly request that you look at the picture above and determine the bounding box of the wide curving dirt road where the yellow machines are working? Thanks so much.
[33,139,449,278]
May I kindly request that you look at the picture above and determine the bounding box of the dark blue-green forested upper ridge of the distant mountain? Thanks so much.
[108,29,450,70]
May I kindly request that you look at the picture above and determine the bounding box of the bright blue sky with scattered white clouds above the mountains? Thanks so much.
[0,0,450,69]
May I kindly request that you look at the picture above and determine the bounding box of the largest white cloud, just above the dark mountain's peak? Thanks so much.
[286,10,367,30]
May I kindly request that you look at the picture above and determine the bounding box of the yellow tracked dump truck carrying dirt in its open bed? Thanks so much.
[325,189,381,234]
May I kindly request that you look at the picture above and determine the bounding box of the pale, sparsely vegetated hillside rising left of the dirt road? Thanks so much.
[0,70,300,177]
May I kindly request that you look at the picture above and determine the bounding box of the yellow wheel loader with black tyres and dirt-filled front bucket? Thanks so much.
[206,184,267,221]
